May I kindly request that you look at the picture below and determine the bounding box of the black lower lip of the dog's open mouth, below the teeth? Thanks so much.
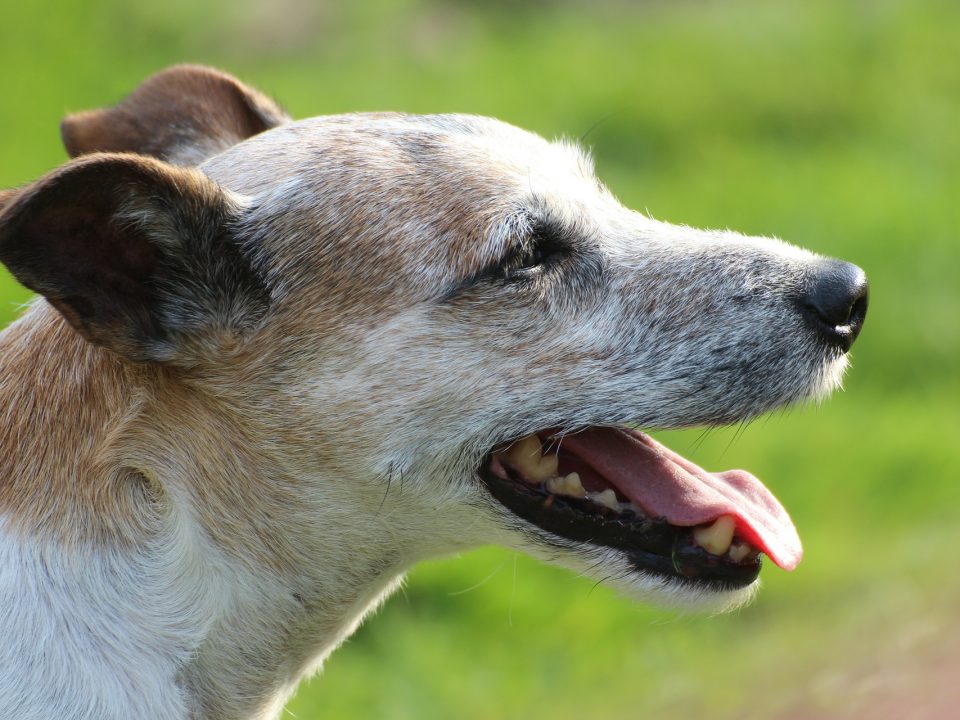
[479,456,762,591]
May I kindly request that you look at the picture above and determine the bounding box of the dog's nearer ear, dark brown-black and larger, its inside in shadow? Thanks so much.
[0,154,269,362]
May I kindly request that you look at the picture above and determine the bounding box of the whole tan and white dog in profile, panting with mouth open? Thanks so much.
[0,66,867,720]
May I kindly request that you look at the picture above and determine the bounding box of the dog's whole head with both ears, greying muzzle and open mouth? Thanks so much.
[0,67,866,607]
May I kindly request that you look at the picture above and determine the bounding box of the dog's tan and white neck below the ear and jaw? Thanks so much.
[0,301,412,718]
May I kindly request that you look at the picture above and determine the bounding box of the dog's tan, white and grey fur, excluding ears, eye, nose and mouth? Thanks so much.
[0,68,846,720]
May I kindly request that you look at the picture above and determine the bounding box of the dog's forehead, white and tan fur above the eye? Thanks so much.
[201,114,597,300]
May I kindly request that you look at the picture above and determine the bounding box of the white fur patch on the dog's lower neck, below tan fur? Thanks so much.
[0,510,207,720]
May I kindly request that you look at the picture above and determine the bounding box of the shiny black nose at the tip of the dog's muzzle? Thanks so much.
[800,260,867,352]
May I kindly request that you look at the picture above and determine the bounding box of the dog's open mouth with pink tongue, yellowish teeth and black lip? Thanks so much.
[480,426,803,590]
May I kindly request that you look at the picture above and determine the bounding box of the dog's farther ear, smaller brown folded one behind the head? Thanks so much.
[60,65,290,166]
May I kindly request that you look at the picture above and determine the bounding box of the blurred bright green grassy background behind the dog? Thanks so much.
[0,0,960,720]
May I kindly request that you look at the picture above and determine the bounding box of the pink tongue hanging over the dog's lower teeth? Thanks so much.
[560,427,803,570]
